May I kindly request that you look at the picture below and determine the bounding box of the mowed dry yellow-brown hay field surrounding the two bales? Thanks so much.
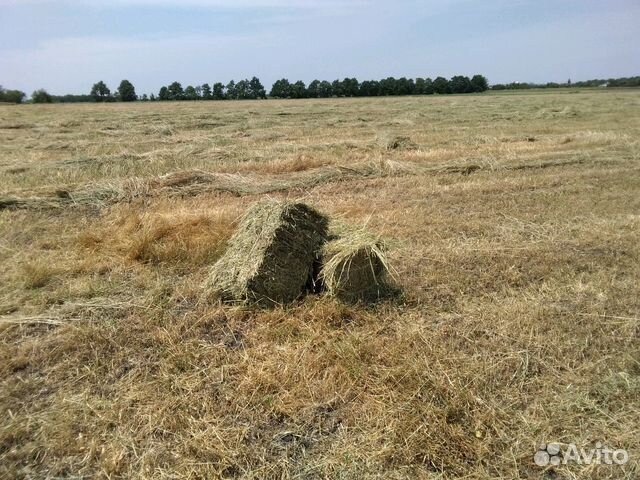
[0,90,640,479]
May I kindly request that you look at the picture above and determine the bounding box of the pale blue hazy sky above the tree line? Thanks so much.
[0,0,640,94]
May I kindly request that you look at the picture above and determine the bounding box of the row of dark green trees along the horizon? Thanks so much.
[0,75,640,103]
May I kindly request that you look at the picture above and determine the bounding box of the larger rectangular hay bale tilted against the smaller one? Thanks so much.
[206,200,328,305]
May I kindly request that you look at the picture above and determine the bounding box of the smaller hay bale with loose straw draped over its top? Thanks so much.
[320,229,395,302]
